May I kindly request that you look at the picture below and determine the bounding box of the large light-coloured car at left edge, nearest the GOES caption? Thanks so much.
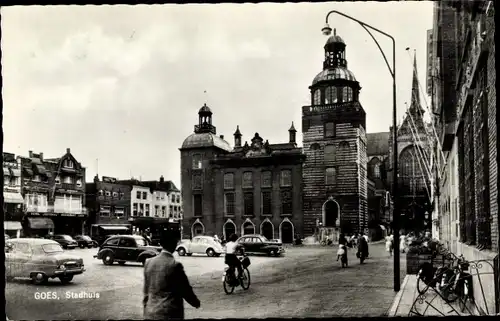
[5,238,85,284]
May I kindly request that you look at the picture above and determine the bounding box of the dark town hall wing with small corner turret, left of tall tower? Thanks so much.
[180,105,304,243]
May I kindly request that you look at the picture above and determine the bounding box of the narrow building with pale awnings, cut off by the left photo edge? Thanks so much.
[2,153,24,237]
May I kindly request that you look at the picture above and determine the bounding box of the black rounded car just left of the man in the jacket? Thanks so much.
[94,235,162,265]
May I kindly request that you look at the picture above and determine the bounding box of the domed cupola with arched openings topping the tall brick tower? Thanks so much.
[309,29,361,105]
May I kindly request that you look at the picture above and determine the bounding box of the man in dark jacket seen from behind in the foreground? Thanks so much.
[142,231,200,320]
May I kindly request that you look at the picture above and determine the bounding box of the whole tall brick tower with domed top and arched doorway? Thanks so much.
[302,31,368,235]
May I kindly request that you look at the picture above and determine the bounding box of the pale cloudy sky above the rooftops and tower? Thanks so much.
[1,1,432,187]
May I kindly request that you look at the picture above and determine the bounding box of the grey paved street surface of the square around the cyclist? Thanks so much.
[6,244,405,320]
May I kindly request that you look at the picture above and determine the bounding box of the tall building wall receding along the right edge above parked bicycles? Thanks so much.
[429,1,500,312]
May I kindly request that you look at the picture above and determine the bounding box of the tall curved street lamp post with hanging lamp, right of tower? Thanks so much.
[321,10,401,291]
